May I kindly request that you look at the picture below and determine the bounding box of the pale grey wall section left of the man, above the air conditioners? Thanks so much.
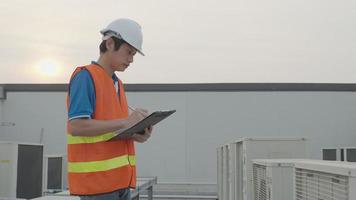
[0,92,67,154]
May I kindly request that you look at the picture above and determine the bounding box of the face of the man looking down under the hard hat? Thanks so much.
[108,38,136,71]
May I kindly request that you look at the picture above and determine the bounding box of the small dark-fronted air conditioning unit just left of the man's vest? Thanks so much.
[43,155,67,192]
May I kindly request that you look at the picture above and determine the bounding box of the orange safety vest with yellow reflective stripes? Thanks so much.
[67,64,136,195]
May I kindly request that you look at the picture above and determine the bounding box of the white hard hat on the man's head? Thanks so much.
[100,19,145,56]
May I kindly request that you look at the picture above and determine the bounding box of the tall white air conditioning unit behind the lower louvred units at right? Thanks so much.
[218,138,306,200]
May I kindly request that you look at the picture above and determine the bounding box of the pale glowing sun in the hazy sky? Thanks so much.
[36,58,61,77]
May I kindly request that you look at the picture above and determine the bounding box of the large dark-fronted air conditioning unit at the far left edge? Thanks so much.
[0,142,43,199]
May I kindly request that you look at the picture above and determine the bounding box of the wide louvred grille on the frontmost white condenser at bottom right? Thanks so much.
[295,168,349,200]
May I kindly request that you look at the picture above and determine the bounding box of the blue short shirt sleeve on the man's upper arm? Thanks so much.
[68,69,95,120]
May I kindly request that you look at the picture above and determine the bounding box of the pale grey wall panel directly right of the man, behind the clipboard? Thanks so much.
[127,92,189,182]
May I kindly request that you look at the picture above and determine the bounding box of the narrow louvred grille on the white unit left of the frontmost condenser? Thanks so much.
[253,164,267,200]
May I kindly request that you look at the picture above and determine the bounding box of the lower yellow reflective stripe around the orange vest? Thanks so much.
[68,155,136,173]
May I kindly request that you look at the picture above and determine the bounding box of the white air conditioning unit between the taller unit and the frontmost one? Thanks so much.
[252,159,302,200]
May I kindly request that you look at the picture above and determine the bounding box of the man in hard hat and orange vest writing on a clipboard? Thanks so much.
[67,19,152,200]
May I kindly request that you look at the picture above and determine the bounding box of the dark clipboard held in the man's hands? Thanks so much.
[109,110,176,141]
